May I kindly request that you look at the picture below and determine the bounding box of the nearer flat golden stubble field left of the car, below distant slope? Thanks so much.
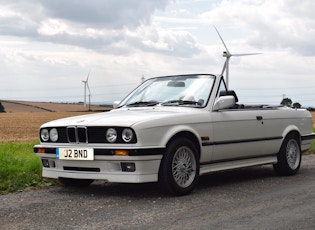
[0,112,99,143]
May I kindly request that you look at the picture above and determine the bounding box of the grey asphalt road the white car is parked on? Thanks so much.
[0,155,315,230]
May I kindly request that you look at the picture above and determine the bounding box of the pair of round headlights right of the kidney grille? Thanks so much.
[106,128,135,143]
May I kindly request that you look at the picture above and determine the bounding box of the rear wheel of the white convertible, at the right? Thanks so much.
[273,133,302,176]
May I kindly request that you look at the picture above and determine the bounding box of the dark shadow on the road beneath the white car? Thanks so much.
[53,166,278,198]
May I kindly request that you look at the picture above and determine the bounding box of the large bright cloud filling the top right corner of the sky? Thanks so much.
[199,0,315,55]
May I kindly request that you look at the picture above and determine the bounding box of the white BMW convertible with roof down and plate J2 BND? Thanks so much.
[34,74,315,195]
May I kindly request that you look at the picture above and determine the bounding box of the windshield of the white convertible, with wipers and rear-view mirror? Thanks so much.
[119,75,215,107]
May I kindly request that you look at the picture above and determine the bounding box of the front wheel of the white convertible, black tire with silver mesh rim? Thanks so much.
[159,138,199,196]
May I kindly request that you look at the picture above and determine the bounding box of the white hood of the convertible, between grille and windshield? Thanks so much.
[42,107,204,127]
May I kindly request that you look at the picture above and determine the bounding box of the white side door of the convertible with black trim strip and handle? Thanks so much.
[211,109,265,162]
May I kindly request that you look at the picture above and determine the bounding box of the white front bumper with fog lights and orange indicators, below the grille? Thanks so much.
[34,145,163,183]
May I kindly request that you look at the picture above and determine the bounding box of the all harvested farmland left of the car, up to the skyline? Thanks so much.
[0,101,110,143]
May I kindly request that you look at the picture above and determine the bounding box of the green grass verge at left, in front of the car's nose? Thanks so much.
[0,143,55,194]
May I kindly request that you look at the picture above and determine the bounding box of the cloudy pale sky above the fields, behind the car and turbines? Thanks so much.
[0,0,315,107]
